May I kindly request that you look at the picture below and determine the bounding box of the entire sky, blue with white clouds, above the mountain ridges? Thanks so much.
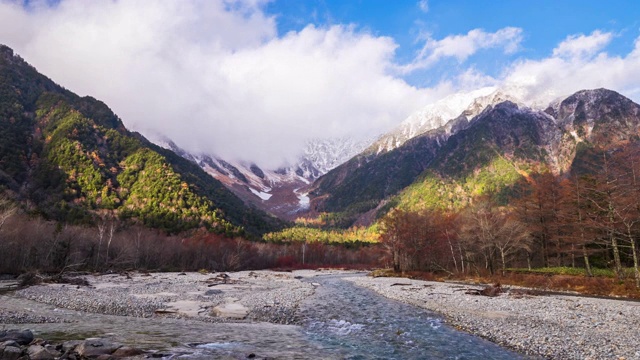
[0,0,640,168]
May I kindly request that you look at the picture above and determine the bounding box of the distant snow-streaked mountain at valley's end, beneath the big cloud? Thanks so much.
[153,136,372,220]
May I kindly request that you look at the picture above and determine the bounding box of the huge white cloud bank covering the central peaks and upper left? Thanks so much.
[0,0,444,167]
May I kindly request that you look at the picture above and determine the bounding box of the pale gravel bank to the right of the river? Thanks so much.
[346,277,640,360]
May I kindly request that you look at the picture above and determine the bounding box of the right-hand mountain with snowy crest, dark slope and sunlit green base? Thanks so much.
[310,89,640,226]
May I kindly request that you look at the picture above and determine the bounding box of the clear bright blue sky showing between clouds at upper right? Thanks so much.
[265,0,640,86]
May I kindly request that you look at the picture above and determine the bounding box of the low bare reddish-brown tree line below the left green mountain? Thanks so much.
[0,205,382,274]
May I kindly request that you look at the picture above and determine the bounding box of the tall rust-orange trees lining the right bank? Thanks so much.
[380,146,640,287]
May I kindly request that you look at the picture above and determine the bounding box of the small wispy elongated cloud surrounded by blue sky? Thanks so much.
[400,27,522,73]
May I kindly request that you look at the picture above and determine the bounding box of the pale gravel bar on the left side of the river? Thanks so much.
[5,271,313,324]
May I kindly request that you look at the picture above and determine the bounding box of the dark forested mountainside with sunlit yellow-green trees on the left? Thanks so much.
[0,46,281,236]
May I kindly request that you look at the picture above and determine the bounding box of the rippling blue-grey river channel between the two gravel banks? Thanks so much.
[301,275,525,360]
